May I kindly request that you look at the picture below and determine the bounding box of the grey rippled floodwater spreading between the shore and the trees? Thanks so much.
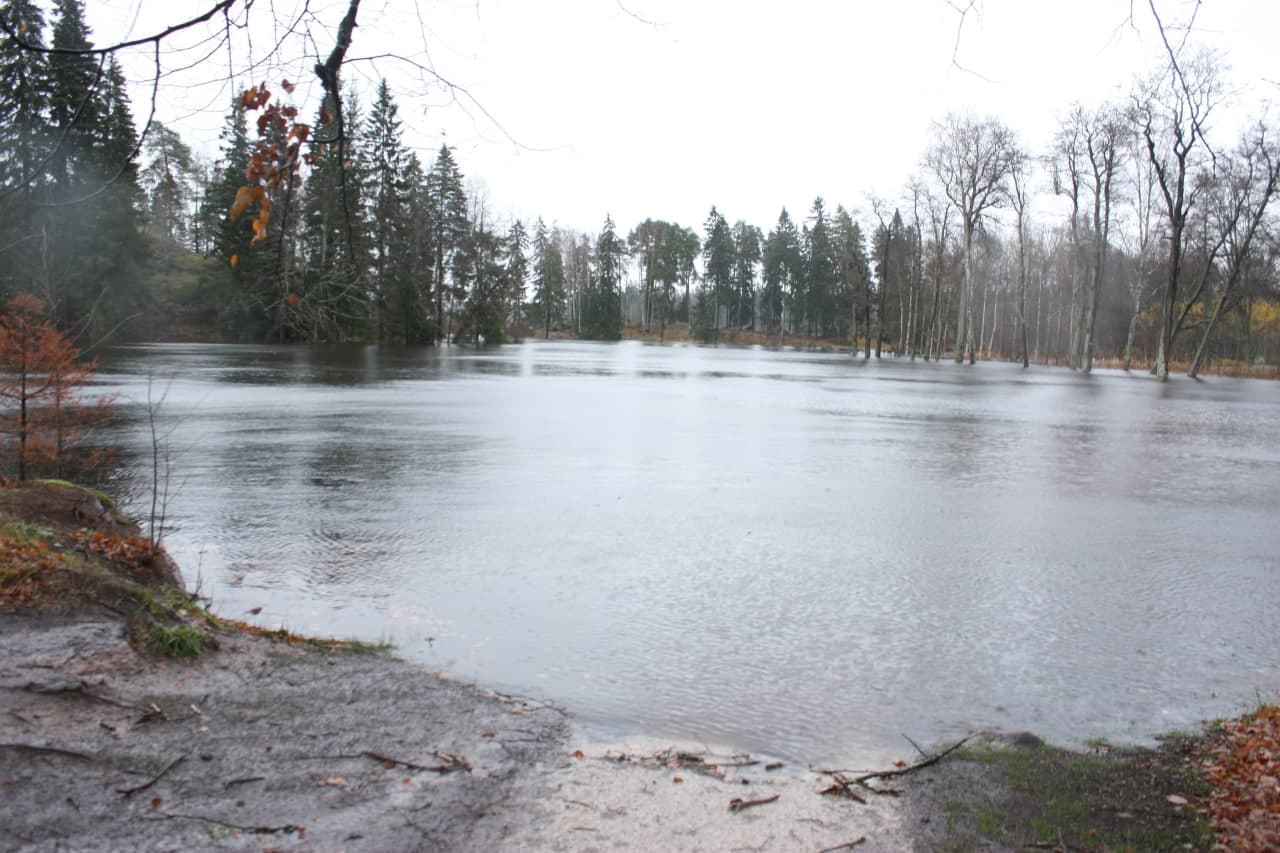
[102,342,1280,766]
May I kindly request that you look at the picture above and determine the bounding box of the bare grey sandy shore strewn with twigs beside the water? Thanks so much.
[0,615,913,852]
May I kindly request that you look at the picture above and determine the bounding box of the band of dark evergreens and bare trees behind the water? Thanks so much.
[0,0,1280,369]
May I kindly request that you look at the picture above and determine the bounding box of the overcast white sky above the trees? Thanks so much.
[87,0,1280,232]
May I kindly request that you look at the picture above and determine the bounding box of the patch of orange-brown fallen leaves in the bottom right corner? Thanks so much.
[1199,706,1280,852]
